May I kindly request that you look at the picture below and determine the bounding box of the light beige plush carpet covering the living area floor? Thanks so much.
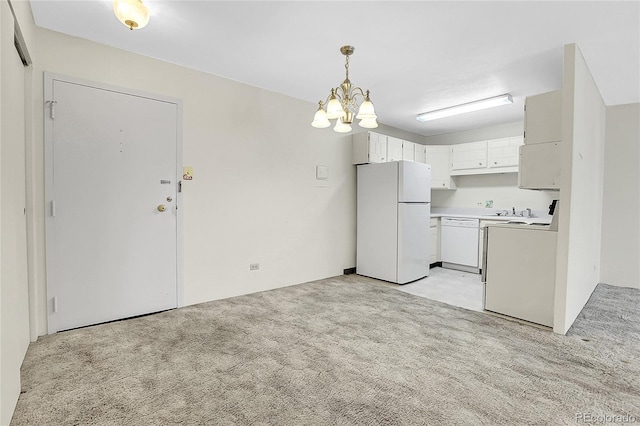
[11,275,640,426]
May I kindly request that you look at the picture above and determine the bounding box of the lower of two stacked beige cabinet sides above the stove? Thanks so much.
[518,142,562,189]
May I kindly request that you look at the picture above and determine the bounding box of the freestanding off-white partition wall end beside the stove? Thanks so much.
[553,44,606,334]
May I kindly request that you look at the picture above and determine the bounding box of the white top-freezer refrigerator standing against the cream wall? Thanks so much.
[356,161,431,284]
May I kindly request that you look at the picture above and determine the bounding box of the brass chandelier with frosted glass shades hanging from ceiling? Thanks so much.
[311,46,378,133]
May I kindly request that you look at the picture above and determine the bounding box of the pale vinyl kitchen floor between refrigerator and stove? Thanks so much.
[394,267,483,312]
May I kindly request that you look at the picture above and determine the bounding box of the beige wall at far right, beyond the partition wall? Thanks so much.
[600,104,640,288]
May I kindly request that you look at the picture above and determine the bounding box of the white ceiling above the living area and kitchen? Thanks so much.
[31,0,640,135]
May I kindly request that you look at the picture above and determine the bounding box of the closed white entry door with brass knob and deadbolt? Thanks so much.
[45,77,180,333]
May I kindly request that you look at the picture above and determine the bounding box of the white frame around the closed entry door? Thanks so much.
[43,71,184,334]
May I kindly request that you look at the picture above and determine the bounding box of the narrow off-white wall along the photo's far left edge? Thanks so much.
[0,1,33,425]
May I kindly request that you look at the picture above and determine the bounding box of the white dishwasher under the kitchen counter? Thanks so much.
[440,217,480,273]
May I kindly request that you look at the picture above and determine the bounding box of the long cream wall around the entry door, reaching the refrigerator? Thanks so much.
[33,28,356,334]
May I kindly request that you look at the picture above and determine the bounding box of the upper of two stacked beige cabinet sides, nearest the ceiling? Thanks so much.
[524,90,562,145]
